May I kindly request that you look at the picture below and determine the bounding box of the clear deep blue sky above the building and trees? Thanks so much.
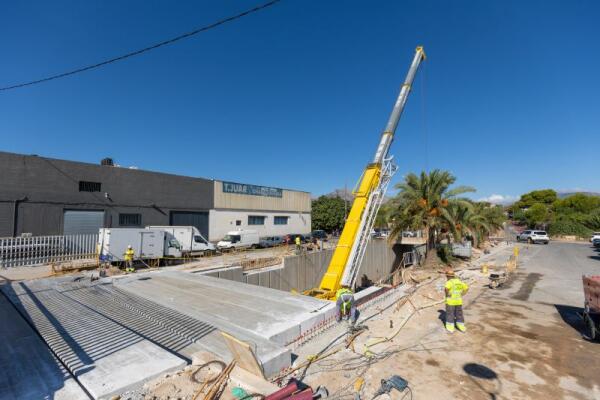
[0,0,600,203]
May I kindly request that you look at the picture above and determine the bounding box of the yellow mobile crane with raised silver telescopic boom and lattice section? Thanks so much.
[305,46,425,300]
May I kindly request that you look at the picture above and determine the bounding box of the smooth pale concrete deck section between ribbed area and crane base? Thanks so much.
[114,271,333,376]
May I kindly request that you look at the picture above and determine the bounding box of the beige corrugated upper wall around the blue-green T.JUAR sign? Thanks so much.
[214,181,311,212]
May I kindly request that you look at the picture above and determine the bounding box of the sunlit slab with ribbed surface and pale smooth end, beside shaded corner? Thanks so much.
[2,280,186,398]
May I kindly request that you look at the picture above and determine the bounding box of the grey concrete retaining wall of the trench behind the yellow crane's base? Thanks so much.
[200,239,402,292]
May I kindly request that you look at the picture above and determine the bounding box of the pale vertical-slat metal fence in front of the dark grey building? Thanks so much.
[0,234,98,268]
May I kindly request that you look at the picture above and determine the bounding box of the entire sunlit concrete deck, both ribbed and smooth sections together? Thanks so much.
[2,270,333,398]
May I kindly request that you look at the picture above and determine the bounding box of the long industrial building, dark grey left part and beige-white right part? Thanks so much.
[0,152,311,241]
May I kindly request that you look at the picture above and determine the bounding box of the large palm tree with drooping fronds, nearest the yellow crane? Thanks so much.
[390,169,475,251]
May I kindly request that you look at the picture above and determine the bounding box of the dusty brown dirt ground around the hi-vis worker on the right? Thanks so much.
[284,244,600,399]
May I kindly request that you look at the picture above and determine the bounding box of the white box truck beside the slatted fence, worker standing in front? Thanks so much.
[98,228,181,262]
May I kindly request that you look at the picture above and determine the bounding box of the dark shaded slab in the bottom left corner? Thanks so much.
[0,295,89,400]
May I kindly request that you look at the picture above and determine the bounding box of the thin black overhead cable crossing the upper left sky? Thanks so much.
[0,0,281,91]
